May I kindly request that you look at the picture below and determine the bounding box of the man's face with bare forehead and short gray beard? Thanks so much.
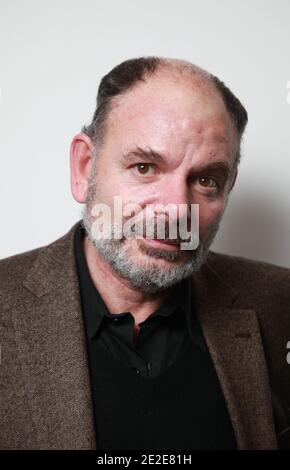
[84,72,238,293]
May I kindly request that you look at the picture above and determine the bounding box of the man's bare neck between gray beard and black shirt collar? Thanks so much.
[84,238,173,325]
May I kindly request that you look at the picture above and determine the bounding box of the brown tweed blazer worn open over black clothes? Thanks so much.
[0,222,290,449]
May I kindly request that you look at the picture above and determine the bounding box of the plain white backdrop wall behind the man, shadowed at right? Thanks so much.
[0,0,290,267]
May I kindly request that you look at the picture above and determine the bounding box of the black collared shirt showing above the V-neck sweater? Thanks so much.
[75,220,206,378]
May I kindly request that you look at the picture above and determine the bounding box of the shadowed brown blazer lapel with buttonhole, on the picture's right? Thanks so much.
[193,264,277,450]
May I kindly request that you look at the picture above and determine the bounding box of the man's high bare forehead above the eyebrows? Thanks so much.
[108,73,237,161]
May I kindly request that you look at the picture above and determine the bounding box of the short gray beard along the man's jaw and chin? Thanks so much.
[82,204,221,294]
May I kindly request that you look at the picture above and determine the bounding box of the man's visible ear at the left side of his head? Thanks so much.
[70,134,94,203]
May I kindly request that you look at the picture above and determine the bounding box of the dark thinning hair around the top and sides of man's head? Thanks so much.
[82,56,248,164]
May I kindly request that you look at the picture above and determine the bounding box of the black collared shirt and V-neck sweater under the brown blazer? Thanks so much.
[74,222,236,449]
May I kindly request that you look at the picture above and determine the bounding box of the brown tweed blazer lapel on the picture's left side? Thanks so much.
[12,222,96,449]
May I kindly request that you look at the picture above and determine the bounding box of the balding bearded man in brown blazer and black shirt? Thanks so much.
[0,57,290,449]
